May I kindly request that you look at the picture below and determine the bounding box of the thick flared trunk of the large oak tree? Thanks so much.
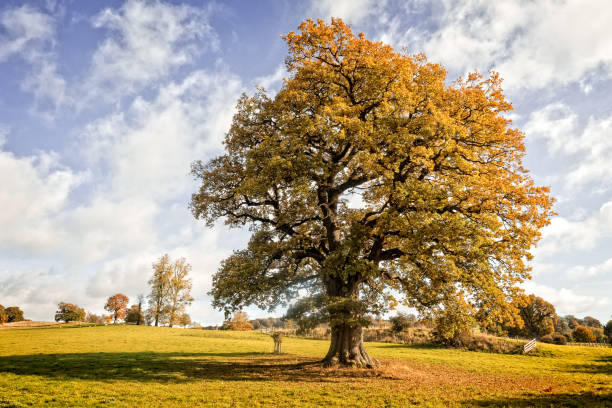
[322,325,379,368]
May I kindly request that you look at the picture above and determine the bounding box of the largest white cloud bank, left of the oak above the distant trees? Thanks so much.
[0,66,244,320]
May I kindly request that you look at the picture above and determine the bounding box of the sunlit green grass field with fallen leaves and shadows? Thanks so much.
[0,326,612,408]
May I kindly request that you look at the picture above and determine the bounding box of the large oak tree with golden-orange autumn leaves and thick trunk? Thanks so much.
[191,19,552,366]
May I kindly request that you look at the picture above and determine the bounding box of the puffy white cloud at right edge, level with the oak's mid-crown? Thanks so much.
[524,103,612,191]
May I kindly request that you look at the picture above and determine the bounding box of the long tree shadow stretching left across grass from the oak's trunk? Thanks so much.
[0,352,382,383]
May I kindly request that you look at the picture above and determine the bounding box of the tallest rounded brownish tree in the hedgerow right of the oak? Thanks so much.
[510,295,557,337]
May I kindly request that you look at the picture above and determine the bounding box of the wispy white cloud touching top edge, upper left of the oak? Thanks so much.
[85,0,217,100]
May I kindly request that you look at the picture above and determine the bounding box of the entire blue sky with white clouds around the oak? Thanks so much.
[0,0,612,324]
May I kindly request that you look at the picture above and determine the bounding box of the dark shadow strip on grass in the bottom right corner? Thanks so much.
[464,392,612,408]
